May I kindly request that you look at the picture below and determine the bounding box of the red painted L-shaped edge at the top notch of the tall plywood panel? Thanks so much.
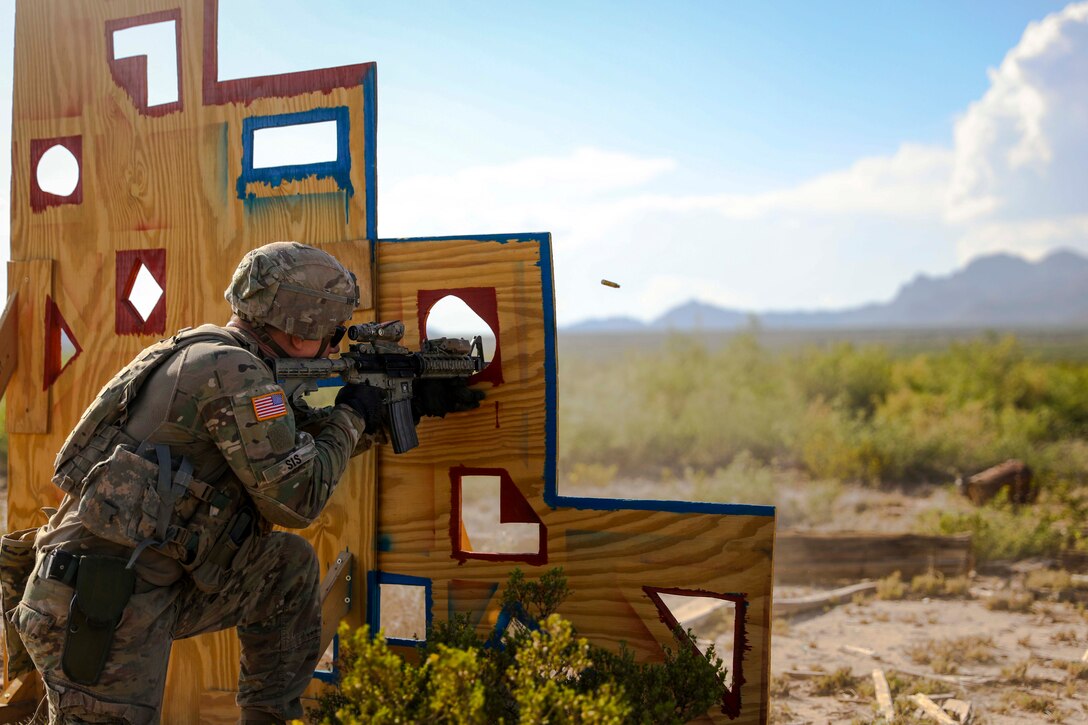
[202,0,374,106]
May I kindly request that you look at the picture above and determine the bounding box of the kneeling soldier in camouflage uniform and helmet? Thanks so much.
[11,242,478,723]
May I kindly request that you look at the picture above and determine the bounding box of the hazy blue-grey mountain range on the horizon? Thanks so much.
[566,250,1088,332]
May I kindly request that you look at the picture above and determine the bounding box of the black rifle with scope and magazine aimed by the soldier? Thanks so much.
[272,320,484,453]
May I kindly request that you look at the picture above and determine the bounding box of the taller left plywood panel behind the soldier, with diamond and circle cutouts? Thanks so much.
[7,0,376,723]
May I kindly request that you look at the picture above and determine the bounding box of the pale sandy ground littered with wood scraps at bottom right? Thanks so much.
[771,577,1088,725]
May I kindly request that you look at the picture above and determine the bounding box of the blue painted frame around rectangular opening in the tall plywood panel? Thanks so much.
[236,106,352,200]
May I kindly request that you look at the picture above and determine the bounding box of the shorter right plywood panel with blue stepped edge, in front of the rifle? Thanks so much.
[368,234,775,723]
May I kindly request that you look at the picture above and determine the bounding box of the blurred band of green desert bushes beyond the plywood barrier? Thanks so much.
[559,331,1088,487]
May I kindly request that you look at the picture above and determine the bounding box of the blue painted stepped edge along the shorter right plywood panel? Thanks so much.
[379,232,775,517]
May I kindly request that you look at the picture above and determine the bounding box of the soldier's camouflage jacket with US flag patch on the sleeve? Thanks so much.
[36,325,380,585]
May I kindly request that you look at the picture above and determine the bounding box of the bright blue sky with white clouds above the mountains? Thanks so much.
[0,0,1088,323]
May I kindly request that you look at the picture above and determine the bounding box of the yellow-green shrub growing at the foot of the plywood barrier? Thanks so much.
[307,569,727,725]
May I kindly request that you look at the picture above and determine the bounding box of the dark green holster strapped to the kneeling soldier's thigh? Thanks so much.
[61,555,136,685]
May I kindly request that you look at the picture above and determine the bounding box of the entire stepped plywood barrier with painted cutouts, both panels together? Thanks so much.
[7,0,774,723]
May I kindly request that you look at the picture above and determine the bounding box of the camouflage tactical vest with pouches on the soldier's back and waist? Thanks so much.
[52,325,257,591]
